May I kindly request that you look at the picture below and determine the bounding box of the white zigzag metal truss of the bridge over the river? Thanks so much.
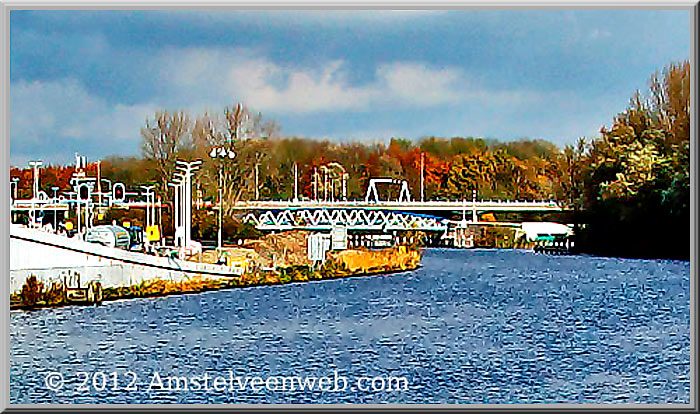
[243,208,449,232]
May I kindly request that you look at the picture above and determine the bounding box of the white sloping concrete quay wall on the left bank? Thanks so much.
[10,226,235,294]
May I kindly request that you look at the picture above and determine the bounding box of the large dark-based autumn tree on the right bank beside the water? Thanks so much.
[584,61,690,257]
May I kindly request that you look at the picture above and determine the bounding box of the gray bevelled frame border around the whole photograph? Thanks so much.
[0,0,699,412]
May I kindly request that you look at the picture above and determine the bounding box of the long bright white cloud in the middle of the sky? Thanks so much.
[157,48,491,113]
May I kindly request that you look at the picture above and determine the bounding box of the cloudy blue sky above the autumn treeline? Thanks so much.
[10,10,690,166]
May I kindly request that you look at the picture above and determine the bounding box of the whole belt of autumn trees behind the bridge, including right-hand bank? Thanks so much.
[11,61,690,259]
